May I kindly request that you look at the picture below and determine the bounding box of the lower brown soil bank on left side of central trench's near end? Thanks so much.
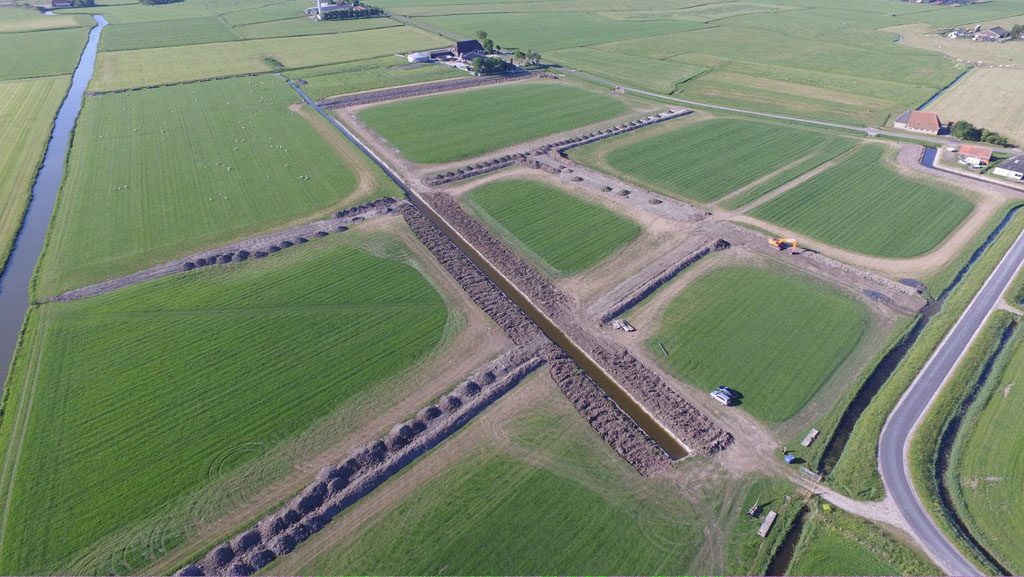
[548,349,672,477]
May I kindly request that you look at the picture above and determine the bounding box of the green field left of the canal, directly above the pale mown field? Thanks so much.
[0,28,89,80]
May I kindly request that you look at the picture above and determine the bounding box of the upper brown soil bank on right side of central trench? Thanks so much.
[427,193,572,318]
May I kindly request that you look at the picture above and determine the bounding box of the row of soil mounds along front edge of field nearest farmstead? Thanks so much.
[423,109,693,187]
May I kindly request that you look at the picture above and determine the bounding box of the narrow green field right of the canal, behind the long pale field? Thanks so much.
[99,17,242,52]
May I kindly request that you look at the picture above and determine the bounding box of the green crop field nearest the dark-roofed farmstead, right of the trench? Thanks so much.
[359,83,626,164]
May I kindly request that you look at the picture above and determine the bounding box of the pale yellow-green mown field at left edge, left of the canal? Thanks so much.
[0,76,71,271]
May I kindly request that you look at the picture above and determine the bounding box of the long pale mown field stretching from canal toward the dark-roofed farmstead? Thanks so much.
[89,26,444,91]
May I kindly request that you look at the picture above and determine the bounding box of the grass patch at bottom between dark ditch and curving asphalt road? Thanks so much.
[785,503,939,575]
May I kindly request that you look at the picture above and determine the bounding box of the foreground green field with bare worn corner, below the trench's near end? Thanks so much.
[272,375,704,575]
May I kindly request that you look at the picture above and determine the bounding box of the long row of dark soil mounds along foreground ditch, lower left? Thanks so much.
[177,346,543,575]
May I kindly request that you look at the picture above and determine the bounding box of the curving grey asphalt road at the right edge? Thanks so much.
[879,224,1024,575]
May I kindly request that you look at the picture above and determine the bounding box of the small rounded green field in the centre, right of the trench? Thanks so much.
[469,180,640,275]
